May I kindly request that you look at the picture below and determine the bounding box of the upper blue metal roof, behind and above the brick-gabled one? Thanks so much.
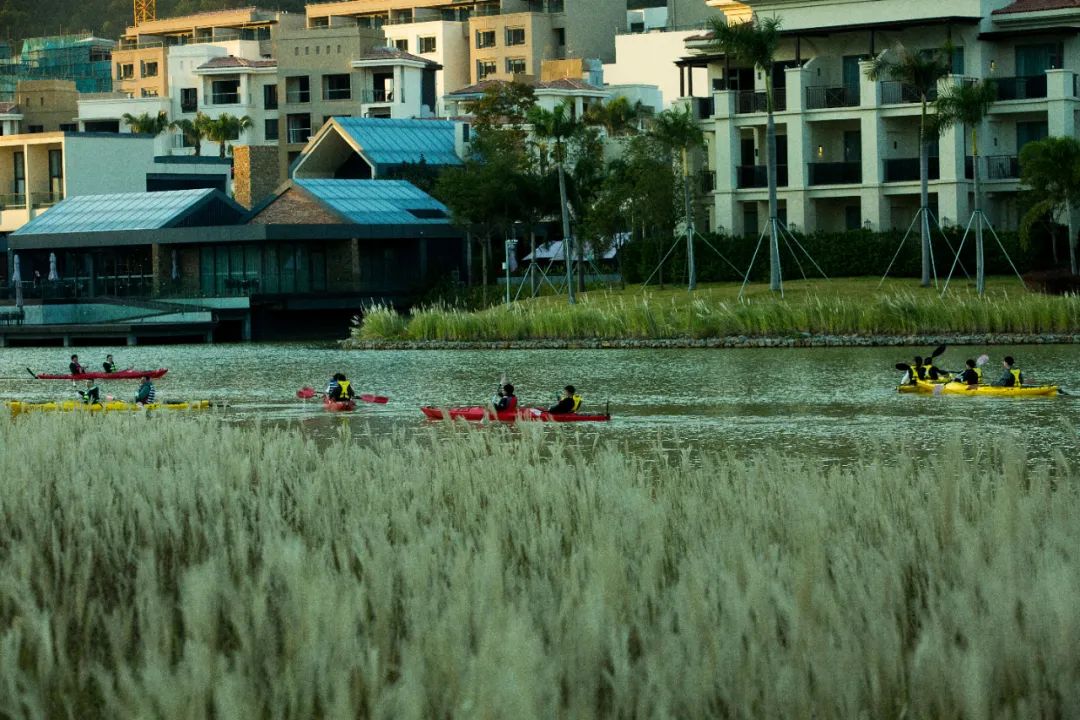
[336,118,461,170]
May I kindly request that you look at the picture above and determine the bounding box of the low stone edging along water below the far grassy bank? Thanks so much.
[338,332,1080,351]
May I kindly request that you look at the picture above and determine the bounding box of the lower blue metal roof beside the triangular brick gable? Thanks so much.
[293,180,449,225]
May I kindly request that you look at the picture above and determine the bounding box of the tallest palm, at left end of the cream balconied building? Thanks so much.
[708,15,780,290]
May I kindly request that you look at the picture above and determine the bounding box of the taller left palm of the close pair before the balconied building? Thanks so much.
[866,45,953,287]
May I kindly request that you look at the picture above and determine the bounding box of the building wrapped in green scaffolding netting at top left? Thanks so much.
[0,35,116,96]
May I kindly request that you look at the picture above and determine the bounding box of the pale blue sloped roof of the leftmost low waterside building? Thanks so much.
[12,188,246,235]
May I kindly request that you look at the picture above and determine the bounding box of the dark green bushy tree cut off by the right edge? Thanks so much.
[1020,137,1080,275]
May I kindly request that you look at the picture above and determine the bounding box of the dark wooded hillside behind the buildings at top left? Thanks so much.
[0,0,305,47]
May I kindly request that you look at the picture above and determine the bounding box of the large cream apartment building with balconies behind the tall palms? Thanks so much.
[679,0,1080,233]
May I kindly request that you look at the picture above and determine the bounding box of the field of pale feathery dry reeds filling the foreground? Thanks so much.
[0,416,1080,719]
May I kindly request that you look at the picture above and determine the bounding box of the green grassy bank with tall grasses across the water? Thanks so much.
[351,279,1080,341]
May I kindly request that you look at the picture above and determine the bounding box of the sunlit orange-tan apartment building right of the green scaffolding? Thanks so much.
[112,8,291,97]
